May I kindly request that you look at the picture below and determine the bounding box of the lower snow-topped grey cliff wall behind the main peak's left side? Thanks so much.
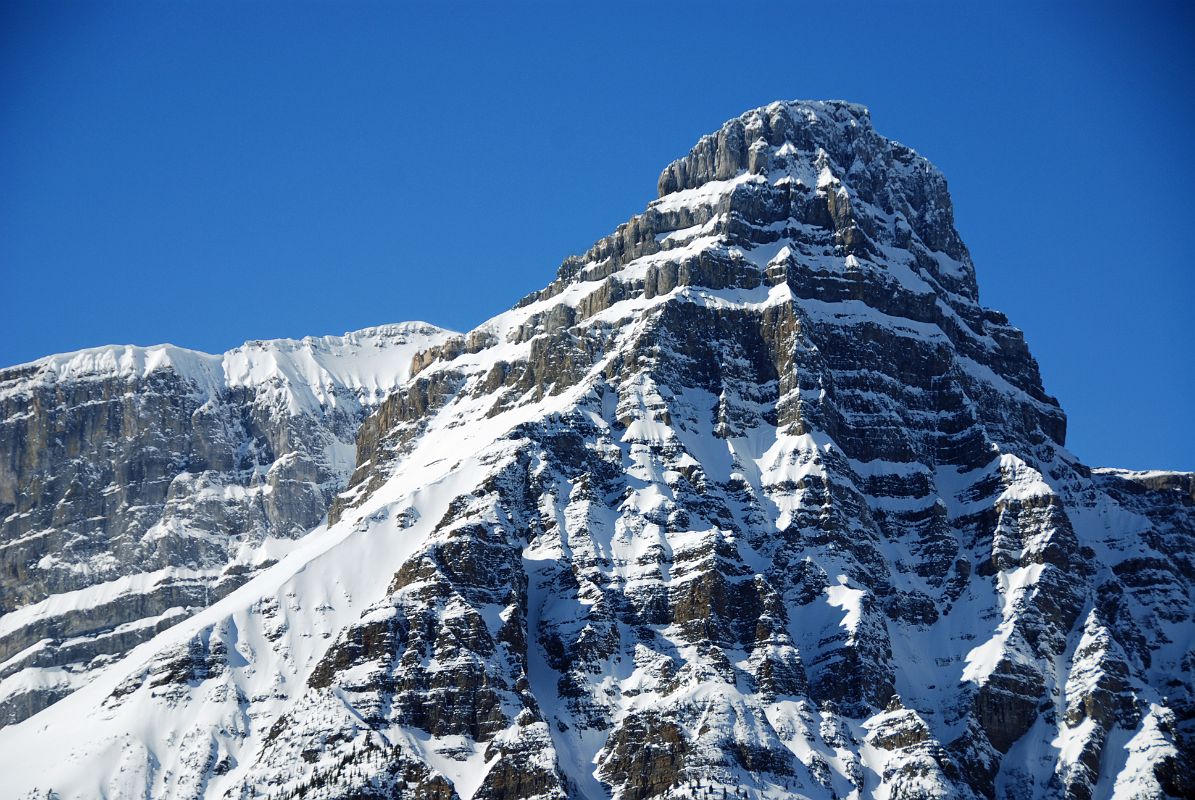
[0,323,448,725]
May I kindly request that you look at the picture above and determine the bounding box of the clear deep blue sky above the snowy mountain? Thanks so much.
[0,0,1195,469]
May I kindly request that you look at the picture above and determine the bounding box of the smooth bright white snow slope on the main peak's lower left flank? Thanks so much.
[0,481,448,796]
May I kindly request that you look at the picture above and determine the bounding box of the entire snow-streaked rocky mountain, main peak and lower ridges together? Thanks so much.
[0,102,1195,800]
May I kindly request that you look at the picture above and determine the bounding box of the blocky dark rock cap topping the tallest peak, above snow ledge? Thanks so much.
[655,100,978,291]
